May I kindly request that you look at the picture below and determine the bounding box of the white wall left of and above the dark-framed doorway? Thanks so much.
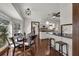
[23,16,41,34]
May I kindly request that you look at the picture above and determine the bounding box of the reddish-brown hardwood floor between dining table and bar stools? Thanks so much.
[2,40,62,56]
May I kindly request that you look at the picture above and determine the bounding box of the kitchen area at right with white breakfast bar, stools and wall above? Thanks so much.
[40,4,72,56]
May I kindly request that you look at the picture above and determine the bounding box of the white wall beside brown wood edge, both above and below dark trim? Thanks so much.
[60,3,72,34]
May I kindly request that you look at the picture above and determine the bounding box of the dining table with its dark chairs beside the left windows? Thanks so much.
[1,33,36,56]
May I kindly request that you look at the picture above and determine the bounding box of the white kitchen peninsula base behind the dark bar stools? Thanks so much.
[40,32,72,56]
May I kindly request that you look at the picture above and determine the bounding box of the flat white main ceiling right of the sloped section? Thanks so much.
[12,3,60,19]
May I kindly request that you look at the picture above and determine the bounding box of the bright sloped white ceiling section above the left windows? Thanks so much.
[0,3,22,20]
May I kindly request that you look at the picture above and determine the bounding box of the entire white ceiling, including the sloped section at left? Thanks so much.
[0,3,60,20]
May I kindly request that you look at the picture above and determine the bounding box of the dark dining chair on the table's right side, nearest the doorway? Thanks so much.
[23,35,36,55]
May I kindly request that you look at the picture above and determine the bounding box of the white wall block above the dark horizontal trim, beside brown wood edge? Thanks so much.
[60,3,72,25]
